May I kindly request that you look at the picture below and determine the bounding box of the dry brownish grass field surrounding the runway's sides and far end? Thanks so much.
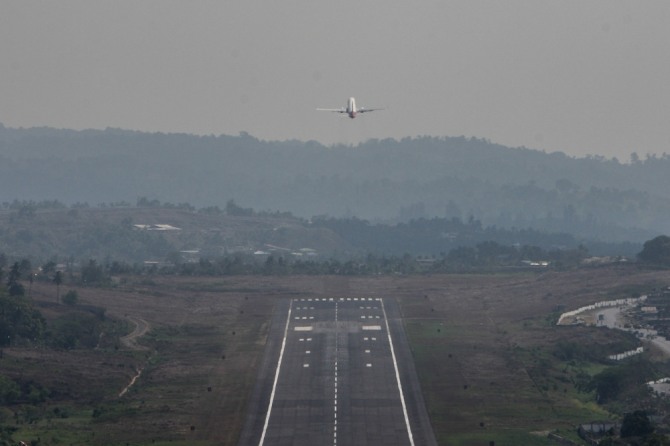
[0,266,670,446]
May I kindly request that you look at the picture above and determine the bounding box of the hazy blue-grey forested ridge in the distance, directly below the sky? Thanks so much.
[0,125,670,242]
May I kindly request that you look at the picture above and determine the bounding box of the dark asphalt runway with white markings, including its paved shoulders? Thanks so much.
[239,297,437,446]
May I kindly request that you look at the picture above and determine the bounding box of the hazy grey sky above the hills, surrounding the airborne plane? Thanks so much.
[0,0,670,161]
